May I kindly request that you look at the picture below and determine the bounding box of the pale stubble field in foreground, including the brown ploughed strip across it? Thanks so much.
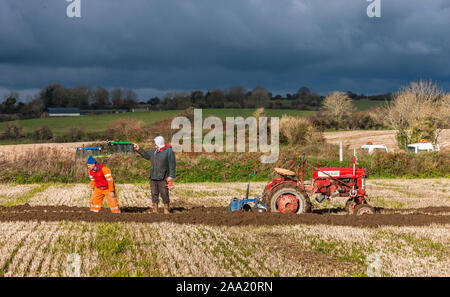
[0,179,450,276]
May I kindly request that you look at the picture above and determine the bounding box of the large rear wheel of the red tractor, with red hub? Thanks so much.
[264,184,311,214]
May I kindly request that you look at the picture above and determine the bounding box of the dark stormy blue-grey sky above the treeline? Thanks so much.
[0,0,450,100]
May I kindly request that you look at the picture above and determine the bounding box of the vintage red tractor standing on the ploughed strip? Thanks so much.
[262,157,375,215]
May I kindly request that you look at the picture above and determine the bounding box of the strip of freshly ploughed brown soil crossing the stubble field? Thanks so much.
[0,204,450,227]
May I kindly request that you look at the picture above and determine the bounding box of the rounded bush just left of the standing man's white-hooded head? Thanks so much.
[108,119,148,141]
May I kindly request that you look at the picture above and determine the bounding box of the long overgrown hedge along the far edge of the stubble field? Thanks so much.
[0,143,450,184]
